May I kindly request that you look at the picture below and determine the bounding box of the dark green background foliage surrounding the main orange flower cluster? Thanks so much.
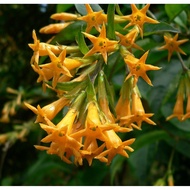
[0,4,190,186]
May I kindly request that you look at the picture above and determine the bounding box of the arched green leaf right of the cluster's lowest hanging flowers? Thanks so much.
[132,130,169,151]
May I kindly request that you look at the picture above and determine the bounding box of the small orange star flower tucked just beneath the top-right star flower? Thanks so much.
[116,28,143,52]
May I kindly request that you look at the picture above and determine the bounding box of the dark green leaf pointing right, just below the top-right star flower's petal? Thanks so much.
[143,22,179,36]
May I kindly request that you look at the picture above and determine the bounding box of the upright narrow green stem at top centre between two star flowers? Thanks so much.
[107,4,116,40]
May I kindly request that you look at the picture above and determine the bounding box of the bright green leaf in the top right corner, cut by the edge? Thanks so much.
[165,4,189,21]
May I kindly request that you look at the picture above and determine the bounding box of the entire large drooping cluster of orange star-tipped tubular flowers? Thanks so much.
[25,5,160,165]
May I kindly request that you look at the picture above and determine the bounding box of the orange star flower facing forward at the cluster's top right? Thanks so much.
[122,4,159,38]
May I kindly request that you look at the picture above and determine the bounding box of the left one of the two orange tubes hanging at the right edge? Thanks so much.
[166,94,184,121]
